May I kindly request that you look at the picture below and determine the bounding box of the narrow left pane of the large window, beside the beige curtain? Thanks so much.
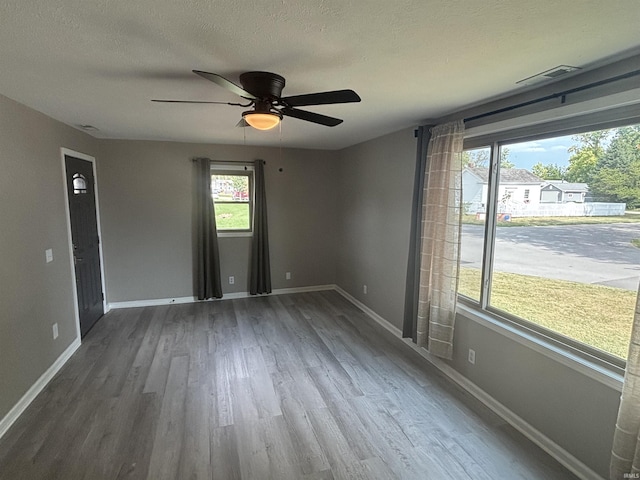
[458,147,491,301]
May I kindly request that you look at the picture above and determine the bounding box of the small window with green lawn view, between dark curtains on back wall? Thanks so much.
[211,166,253,233]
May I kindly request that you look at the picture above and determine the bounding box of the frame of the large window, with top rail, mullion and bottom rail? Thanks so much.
[458,112,640,378]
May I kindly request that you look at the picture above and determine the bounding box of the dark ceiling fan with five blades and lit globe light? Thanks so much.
[151,70,360,130]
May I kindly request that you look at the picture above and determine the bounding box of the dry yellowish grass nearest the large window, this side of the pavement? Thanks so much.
[459,268,636,359]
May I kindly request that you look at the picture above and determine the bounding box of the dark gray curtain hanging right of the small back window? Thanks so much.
[249,160,271,295]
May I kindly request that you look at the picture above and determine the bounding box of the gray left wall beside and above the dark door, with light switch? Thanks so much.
[0,96,98,419]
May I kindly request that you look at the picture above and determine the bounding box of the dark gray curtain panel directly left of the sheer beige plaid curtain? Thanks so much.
[402,125,431,342]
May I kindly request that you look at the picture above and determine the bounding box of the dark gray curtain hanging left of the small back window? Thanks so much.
[194,158,222,300]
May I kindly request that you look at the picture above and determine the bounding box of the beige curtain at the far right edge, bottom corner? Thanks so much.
[610,284,640,480]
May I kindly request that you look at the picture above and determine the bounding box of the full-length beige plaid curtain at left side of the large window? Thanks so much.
[417,120,464,359]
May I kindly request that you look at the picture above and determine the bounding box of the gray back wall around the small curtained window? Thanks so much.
[98,141,337,303]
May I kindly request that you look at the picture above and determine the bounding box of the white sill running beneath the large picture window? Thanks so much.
[458,302,624,392]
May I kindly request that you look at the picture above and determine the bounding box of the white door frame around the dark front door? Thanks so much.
[60,147,109,340]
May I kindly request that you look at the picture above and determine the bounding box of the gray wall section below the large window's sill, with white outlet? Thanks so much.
[452,315,620,478]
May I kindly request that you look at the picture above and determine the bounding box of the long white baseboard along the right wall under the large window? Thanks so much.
[335,286,603,480]
